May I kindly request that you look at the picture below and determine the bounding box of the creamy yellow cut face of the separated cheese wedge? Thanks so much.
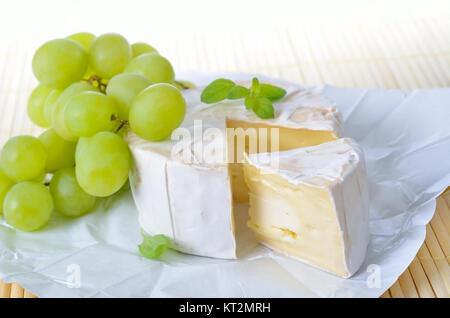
[244,163,348,276]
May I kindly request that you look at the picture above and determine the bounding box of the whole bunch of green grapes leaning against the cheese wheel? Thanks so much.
[0,32,195,231]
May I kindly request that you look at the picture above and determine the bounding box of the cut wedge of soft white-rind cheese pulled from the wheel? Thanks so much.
[244,138,369,277]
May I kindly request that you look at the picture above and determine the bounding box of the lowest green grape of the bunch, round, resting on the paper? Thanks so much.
[3,181,53,232]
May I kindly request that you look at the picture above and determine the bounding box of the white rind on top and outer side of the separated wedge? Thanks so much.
[246,138,370,278]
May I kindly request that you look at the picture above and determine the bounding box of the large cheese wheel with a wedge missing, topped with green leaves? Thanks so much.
[126,82,341,259]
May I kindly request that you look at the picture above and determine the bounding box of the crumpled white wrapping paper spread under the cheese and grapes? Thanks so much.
[0,72,450,297]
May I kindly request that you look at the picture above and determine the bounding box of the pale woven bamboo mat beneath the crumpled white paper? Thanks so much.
[0,16,450,298]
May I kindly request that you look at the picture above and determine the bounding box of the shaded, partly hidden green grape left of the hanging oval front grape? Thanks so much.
[38,129,77,173]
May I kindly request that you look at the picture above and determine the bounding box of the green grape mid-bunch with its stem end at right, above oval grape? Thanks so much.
[64,92,119,137]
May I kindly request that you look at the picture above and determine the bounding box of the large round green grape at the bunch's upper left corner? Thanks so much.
[33,39,88,89]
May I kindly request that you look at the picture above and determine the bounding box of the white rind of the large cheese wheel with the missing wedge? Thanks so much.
[126,82,342,259]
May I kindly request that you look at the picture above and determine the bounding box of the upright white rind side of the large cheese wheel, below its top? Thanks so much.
[130,148,236,259]
